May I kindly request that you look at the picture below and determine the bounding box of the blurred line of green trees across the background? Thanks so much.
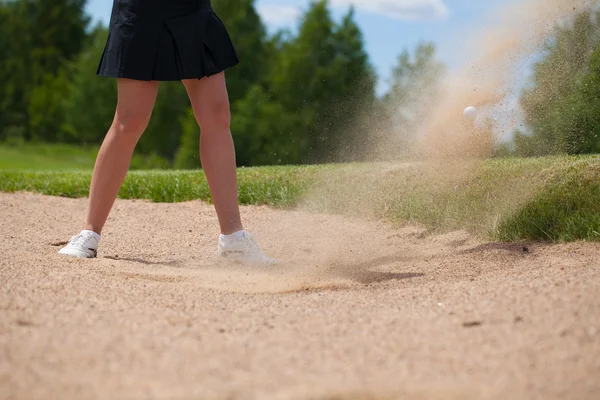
[0,0,600,168]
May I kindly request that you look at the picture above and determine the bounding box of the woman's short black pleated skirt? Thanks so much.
[98,0,239,81]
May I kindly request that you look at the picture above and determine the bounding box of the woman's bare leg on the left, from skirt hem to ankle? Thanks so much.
[85,79,159,235]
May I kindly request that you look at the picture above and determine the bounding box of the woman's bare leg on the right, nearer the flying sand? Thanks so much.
[183,73,244,235]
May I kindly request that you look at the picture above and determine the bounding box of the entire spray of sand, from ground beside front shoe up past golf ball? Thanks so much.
[161,0,591,293]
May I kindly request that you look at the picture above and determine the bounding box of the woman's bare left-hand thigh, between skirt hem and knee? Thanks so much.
[115,79,159,122]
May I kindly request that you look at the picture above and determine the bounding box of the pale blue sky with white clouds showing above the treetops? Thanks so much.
[88,0,509,91]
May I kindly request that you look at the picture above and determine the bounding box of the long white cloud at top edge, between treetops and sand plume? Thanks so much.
[331,0,450,21]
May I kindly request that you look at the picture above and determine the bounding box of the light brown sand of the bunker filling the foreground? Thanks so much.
[0,194,600,400]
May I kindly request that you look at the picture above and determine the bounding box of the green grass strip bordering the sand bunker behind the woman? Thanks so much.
[0,156,600,242]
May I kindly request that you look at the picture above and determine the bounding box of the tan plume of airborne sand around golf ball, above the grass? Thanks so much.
[414,0,594,158]
